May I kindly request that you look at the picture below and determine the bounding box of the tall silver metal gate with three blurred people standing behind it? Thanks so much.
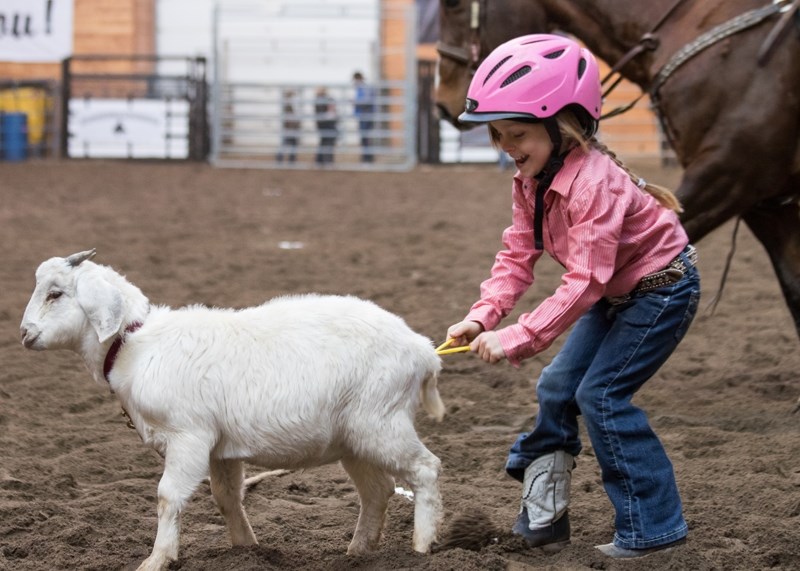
[211,0,417,171]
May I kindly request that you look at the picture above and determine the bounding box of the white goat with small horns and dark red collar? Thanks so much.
[20,250,444,570]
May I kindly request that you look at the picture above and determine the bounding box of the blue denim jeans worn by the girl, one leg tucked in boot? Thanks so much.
[506,254,700,549]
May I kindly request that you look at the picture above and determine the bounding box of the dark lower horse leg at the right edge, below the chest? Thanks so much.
[743,201,800,335]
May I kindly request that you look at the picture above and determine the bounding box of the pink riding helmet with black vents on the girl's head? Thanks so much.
[458,34,601,132]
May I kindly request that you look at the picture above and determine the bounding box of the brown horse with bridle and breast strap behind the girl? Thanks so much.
[436,0,800,340]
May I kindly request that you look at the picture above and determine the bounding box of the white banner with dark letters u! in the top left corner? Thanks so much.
[0,0,73,63]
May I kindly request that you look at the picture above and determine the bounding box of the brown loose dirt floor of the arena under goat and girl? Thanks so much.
[0,161,800,571]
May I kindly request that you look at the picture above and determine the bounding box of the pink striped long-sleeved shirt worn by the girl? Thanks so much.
[465,148,689,366]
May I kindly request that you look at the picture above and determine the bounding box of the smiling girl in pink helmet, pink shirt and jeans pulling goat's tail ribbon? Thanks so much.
[447,34,700,558]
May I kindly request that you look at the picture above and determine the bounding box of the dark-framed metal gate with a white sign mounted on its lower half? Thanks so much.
[61,55,209,160]
